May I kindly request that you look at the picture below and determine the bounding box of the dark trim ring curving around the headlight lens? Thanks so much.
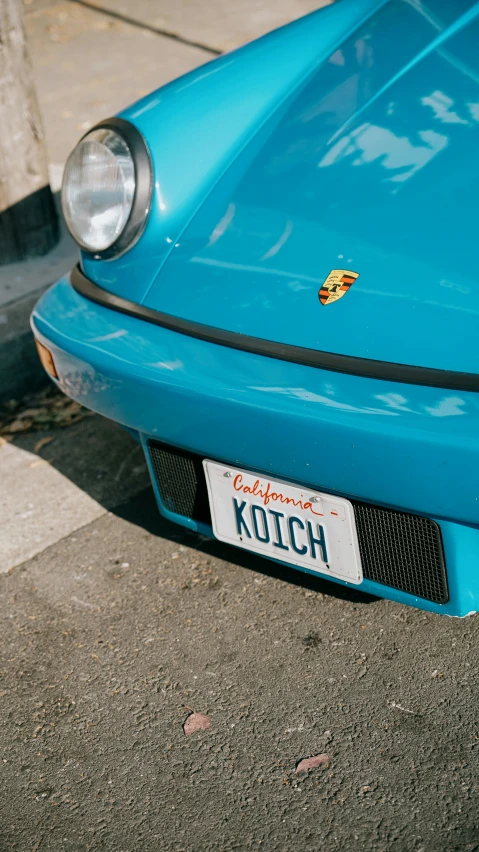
[63,117,153,260]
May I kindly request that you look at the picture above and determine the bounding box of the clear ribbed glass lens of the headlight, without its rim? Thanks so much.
[62,128,135,252]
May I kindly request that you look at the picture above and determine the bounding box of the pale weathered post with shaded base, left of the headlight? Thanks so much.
[0,0,58,264]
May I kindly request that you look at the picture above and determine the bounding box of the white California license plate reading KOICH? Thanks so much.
[203,460,363,584]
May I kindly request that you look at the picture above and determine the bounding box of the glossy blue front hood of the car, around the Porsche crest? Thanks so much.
[143,0,479,372]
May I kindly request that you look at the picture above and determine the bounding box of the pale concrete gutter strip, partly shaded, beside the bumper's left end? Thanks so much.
[0,400,150,572]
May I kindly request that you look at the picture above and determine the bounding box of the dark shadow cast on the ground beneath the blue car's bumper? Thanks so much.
[7,402,378,604]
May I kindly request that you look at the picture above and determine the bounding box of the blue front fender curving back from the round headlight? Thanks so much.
[82,0,385,302]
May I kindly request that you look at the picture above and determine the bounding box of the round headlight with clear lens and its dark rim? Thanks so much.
[62,119,150,256]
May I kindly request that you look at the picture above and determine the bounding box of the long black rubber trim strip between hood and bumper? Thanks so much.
[71,266,479,392]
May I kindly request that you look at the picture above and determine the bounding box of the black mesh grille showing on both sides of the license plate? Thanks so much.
[149,441,449,603]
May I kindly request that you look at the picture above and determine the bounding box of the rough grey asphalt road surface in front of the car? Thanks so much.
[0,403,479,852]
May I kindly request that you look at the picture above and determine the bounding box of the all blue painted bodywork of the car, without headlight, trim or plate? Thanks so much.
[33,0,479,615]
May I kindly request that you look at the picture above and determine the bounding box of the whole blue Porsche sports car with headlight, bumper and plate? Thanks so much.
[32,0,479,616]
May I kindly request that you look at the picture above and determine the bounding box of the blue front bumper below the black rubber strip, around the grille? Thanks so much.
[32,276,479,615]
